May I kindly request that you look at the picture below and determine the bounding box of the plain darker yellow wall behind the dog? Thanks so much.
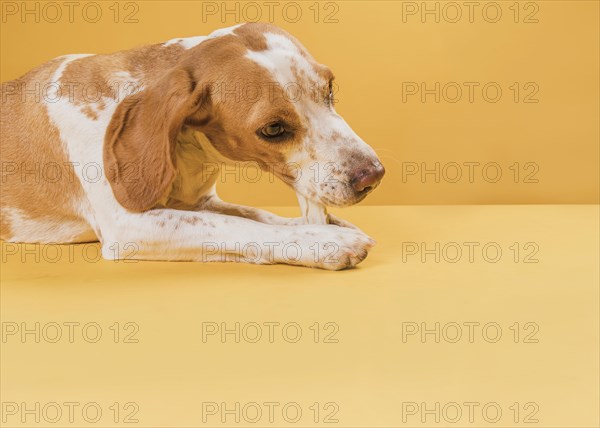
[0,1,600,205]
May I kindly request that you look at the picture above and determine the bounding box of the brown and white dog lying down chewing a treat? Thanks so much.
[0,23,384,270]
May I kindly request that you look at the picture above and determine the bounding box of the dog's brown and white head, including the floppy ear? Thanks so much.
[104,24,384,210]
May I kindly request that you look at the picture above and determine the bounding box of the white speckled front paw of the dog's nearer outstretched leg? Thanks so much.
[294,225,375,270]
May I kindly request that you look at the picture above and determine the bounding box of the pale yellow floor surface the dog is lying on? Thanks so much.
[0,206,599,427]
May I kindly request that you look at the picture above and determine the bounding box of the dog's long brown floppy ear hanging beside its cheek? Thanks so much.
[103,67,205,212]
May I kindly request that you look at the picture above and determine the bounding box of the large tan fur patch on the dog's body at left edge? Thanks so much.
[0,58,84,240]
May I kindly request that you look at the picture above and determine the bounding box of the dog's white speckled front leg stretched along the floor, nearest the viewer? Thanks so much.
[101,209,374,270]
